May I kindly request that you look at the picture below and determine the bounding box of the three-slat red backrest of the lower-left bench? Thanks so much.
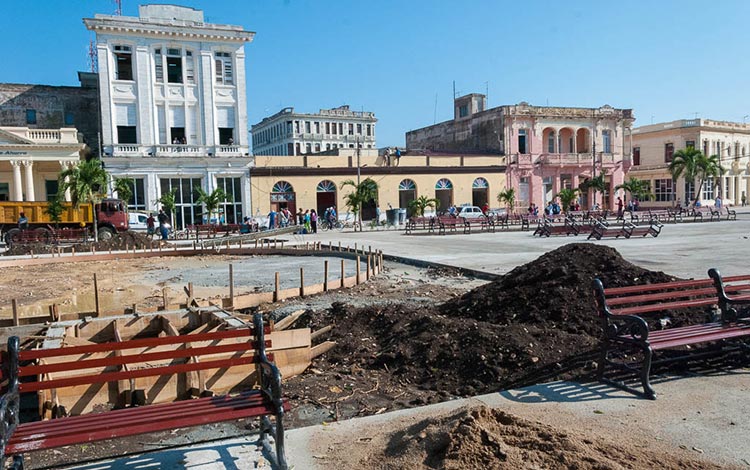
[8,318,273,393]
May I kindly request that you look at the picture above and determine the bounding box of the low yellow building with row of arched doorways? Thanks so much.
[251,149,505,220]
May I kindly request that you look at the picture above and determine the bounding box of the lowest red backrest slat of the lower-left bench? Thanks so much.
[18,354,273,393]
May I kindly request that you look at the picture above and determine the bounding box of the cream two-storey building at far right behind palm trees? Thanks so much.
[629,119,750,206]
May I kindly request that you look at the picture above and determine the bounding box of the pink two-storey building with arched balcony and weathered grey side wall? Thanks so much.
[406,94,634,209]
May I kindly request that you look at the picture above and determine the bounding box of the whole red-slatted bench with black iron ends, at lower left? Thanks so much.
[0,314,289,469]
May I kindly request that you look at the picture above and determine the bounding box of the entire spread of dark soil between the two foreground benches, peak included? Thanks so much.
[287,243,696,424]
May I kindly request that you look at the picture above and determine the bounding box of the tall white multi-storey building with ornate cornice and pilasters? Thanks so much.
[84,5,255,226]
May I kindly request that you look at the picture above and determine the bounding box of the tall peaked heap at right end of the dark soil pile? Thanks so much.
[440,243,674,337]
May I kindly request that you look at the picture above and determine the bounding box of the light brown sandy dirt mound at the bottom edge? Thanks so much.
[363,407,721,470]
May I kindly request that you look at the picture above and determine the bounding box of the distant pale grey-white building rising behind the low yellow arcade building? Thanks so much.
[251,105,377,156]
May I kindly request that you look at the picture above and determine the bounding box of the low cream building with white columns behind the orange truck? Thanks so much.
[0,127,85,201]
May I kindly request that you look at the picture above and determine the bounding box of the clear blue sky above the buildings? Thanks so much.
[0,0,750,147]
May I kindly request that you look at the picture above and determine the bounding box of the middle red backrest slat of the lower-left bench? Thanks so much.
[18,340,271,377]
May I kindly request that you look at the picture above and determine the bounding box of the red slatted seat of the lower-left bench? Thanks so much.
[6,392,290,453]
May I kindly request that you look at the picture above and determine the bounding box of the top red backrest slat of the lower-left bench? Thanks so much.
[18,327,264,361]
